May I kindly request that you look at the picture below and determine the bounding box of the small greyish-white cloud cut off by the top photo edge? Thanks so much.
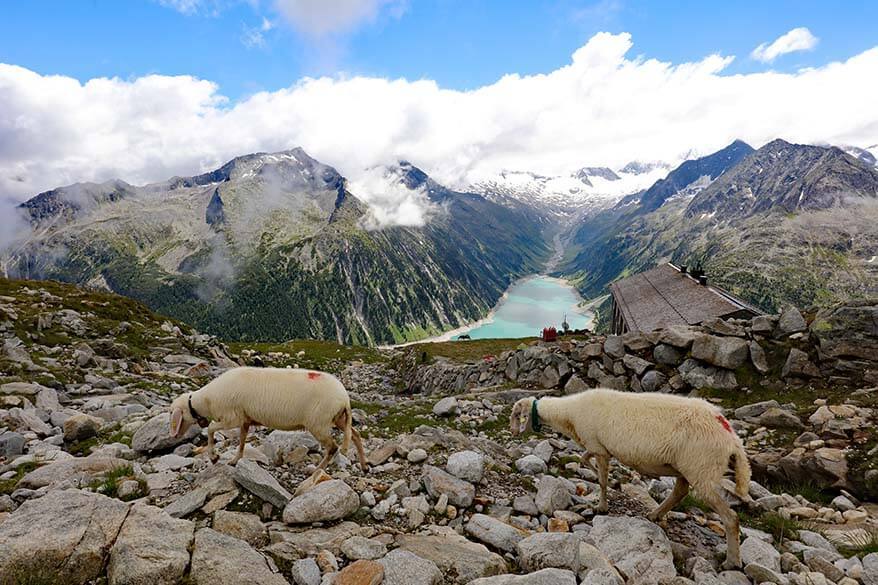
[274,0,407,39]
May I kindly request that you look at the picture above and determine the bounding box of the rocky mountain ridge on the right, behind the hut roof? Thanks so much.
[559,139,878,324]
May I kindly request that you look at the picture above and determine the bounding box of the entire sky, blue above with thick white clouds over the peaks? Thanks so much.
[0,0,878,210]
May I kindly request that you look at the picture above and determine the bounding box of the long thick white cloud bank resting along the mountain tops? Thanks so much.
[0,33,878,228]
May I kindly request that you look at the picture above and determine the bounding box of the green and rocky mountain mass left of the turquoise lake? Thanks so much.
[4,149,549,344]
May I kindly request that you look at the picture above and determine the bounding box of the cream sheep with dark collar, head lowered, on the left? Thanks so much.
[171,367,367,471]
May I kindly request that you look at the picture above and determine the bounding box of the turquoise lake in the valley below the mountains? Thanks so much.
[465,276,592,339]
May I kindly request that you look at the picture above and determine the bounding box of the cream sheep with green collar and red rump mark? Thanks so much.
[510,389,750,567]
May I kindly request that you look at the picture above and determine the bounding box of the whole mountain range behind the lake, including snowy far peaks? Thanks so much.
[2,133,878,344]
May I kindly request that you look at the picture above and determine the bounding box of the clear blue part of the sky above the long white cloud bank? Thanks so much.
[0,0,878,100]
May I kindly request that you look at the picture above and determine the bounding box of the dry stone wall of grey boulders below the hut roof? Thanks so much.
[406,301,878,394]
